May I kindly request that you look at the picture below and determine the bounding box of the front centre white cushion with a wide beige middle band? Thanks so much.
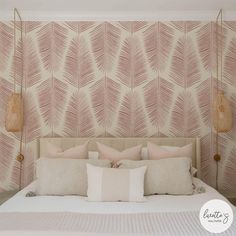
[87,164,146,202]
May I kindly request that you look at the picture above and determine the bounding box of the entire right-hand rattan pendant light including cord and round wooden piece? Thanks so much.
[213,9,232,189]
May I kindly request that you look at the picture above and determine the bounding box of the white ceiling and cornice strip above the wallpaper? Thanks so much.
[0,0,236,20]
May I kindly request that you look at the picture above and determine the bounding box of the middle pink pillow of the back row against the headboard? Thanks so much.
[97,142,142,163]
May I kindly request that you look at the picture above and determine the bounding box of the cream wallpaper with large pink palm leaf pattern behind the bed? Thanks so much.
[0,21,236,196]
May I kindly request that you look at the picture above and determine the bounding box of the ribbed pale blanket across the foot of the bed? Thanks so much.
[0,212,236,236]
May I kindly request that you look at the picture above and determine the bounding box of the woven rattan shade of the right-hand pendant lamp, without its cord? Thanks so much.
[213,91,232,133]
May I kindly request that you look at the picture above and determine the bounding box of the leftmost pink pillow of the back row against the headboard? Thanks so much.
[44,141,89,159]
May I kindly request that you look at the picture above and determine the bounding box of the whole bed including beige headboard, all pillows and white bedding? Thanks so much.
[0,138,236,236]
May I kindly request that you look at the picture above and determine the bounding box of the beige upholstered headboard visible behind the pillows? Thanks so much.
[38,138,201,177]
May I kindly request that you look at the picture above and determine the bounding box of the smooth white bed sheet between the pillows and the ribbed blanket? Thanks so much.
[0,178,236,214]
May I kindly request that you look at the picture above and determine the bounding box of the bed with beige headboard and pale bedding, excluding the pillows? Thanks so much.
[0,138,236,236]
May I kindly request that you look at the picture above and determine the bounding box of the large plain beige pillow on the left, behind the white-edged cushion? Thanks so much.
[36,158,111,196]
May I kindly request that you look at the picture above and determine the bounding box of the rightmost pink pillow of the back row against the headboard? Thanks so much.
[147,142,193,160]
